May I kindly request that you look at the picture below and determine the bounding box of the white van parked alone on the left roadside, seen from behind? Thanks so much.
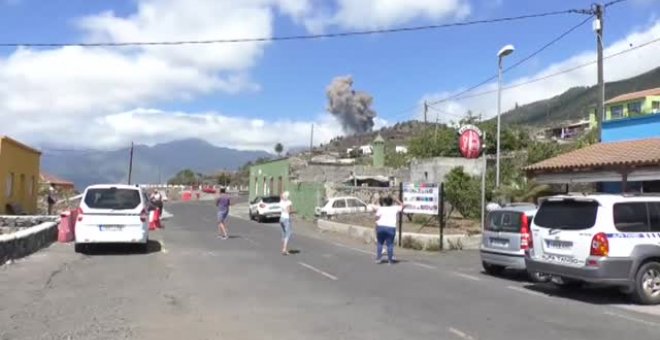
[75,184,149,252]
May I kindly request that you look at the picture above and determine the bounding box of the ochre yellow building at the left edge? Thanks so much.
[0,137,41,214]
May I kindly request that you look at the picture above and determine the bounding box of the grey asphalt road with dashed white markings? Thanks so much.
[0,202,660,340]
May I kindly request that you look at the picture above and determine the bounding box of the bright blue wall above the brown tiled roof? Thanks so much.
[602,114,660,143]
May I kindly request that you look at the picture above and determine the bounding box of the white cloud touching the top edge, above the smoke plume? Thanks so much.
[305,0,471,31]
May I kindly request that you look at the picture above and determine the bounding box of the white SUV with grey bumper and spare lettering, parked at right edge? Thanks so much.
[525,194,660,304]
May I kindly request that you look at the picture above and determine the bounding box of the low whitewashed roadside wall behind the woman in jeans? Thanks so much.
[317,219,481,250]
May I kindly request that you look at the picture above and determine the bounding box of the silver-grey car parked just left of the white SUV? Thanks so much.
[480,203,545,281]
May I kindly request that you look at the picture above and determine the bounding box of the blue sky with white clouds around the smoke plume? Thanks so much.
[0,0,660,152]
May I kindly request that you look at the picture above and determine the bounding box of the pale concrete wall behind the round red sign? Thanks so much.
[410,157,484,183]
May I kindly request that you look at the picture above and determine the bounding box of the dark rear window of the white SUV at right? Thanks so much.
[534,200,598,230]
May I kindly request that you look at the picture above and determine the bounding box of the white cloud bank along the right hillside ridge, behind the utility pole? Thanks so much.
[417,21,660,122]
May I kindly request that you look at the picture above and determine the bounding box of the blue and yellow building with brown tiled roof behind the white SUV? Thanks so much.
[525,88,660,193]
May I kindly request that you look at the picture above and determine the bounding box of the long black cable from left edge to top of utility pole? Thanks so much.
[0,9,579,47]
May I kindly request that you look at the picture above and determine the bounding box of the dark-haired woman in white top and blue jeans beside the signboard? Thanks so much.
[376,196,403,264]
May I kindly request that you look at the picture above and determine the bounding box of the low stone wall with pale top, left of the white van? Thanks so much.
[0,222,58,265]
